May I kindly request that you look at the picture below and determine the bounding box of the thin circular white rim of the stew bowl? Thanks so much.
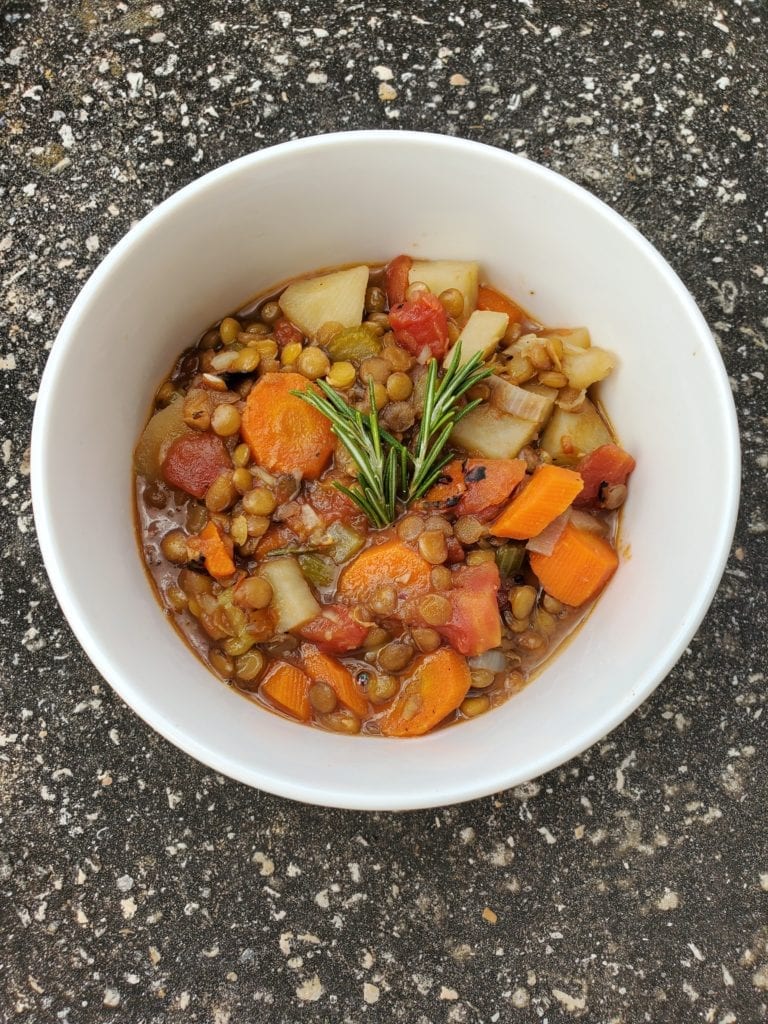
[31,129,740,811]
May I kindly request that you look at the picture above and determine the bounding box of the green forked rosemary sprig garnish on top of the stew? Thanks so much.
[292,343,493,526]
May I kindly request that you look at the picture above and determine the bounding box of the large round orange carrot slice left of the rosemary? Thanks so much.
[241,373,334,480]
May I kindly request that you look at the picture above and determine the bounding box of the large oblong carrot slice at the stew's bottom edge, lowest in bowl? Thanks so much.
[381,647,472,736]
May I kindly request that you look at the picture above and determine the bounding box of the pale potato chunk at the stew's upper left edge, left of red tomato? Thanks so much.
[279,266,369,338]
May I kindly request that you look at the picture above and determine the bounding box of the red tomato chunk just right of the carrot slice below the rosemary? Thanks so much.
[435,562,502,657]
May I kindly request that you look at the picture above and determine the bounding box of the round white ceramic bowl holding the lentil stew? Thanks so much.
[32,132,739,809]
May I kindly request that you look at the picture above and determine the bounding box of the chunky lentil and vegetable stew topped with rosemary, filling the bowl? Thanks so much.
[134,256,635,736]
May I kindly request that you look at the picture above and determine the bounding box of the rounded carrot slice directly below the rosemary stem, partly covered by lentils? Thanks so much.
[338,540,432,604]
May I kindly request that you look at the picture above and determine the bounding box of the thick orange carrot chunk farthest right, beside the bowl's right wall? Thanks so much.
[529,523,618,607]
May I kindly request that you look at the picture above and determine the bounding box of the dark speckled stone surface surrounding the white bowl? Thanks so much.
[0,0,768,1024]
